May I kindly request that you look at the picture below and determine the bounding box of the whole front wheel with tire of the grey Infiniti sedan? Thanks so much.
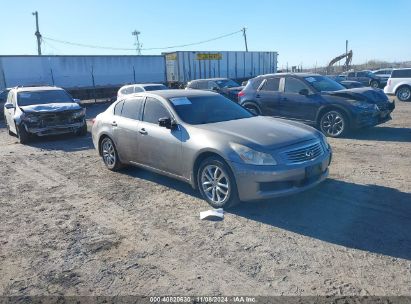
[197,156,240,209]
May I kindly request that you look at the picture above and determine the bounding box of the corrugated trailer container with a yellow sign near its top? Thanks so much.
[164,51,278,83]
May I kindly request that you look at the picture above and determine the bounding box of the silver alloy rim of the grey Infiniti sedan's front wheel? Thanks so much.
[201,165,231,205]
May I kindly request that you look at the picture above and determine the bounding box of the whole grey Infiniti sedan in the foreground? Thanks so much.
[92,90,332,208]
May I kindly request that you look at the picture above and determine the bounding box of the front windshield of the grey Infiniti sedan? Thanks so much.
[170,95,253,125]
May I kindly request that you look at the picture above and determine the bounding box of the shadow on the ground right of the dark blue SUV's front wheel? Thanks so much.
[347,127,411,142]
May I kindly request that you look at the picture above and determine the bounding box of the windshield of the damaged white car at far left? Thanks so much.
[17,90,73,106]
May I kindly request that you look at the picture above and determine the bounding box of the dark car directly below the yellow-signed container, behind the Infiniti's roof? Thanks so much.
[186,78,243,102]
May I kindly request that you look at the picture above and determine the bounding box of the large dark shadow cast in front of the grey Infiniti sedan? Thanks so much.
[228,179,411,260]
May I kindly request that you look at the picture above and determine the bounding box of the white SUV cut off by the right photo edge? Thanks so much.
[384,68,411,101]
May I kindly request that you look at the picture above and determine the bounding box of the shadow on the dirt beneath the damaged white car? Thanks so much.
[26,132,94,152]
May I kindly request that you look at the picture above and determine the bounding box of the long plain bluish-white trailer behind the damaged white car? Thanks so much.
[0,55,166,89]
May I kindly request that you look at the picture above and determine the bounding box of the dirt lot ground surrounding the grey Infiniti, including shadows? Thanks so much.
[0,103,411,295]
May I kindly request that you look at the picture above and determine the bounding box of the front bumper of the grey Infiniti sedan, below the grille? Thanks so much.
[230,151,332,201]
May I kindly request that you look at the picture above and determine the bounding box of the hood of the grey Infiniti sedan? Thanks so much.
[196,116,319,150]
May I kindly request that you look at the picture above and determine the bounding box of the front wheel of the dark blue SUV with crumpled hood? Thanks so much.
[319,109,349,137]
